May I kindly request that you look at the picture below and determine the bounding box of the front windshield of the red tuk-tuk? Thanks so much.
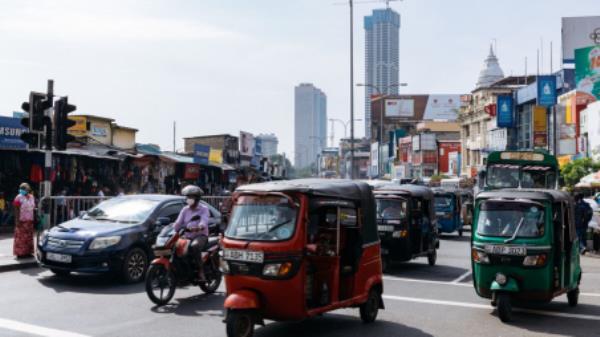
[225,196,297,241]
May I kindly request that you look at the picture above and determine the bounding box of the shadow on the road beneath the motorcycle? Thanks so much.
[151,289,225,317]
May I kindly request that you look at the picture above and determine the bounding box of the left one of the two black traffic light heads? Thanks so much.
[21,91,52,148]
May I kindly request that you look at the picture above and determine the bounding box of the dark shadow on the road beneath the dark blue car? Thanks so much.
[38,274,145,295]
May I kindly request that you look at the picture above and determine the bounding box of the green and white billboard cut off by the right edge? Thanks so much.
[575,46,600,101]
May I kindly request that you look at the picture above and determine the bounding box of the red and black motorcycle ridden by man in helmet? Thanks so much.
[146,220,223,305]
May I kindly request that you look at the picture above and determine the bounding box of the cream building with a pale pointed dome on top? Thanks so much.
[458,46,535,177]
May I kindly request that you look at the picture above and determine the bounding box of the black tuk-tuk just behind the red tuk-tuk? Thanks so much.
[374,184,440,271]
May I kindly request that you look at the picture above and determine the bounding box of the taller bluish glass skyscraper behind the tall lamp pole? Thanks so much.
[364,8,400,139]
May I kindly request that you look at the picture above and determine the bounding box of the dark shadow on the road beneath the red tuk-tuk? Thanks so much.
[254,311,432,337]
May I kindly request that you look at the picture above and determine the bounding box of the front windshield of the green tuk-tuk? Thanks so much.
[477,201,544,238]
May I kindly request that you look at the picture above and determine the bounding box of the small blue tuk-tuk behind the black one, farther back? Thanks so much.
[433,188,463,236]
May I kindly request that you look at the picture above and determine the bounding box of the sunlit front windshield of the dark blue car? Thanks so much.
[83,198,158,223]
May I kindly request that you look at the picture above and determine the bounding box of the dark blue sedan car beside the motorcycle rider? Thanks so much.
[36,195,222,282]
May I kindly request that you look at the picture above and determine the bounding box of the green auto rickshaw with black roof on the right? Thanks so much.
[471,189,581,322]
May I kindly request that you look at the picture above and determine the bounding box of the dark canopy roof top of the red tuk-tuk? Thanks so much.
[236,178,371,200]
